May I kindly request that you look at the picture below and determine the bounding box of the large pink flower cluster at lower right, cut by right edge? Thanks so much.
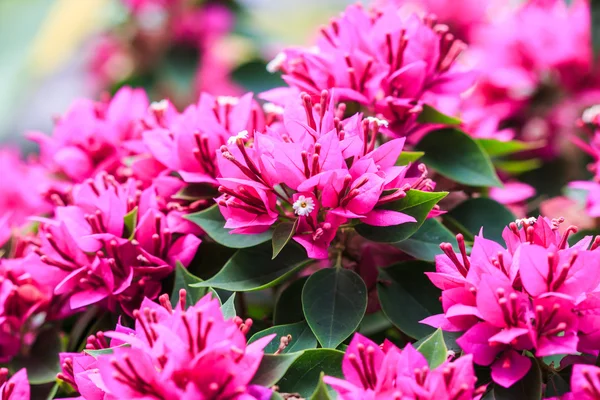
[423,217,600,387]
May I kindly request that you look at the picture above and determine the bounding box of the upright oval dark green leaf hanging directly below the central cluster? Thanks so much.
[302,268,367,348]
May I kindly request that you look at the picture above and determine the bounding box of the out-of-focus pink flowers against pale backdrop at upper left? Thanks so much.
[89,0,239,95]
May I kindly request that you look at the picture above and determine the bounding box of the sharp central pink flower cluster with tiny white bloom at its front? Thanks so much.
[217,90,434,258]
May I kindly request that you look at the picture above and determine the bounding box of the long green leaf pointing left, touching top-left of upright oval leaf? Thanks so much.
[194,244,312,292]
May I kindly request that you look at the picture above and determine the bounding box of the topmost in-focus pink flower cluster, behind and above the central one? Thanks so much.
[268,5,476,136]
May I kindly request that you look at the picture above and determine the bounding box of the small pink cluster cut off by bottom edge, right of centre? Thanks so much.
[324,333,485,400]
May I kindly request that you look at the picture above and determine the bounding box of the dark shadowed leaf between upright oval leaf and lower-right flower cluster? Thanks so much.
[377,261,442,339]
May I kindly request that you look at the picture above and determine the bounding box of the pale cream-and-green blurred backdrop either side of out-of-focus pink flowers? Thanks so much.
[0,0,349,150]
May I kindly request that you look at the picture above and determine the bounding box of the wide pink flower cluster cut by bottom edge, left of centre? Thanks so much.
[58,291,275,400]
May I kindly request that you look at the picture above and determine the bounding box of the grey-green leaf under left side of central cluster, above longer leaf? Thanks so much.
[185,204,273,249]
